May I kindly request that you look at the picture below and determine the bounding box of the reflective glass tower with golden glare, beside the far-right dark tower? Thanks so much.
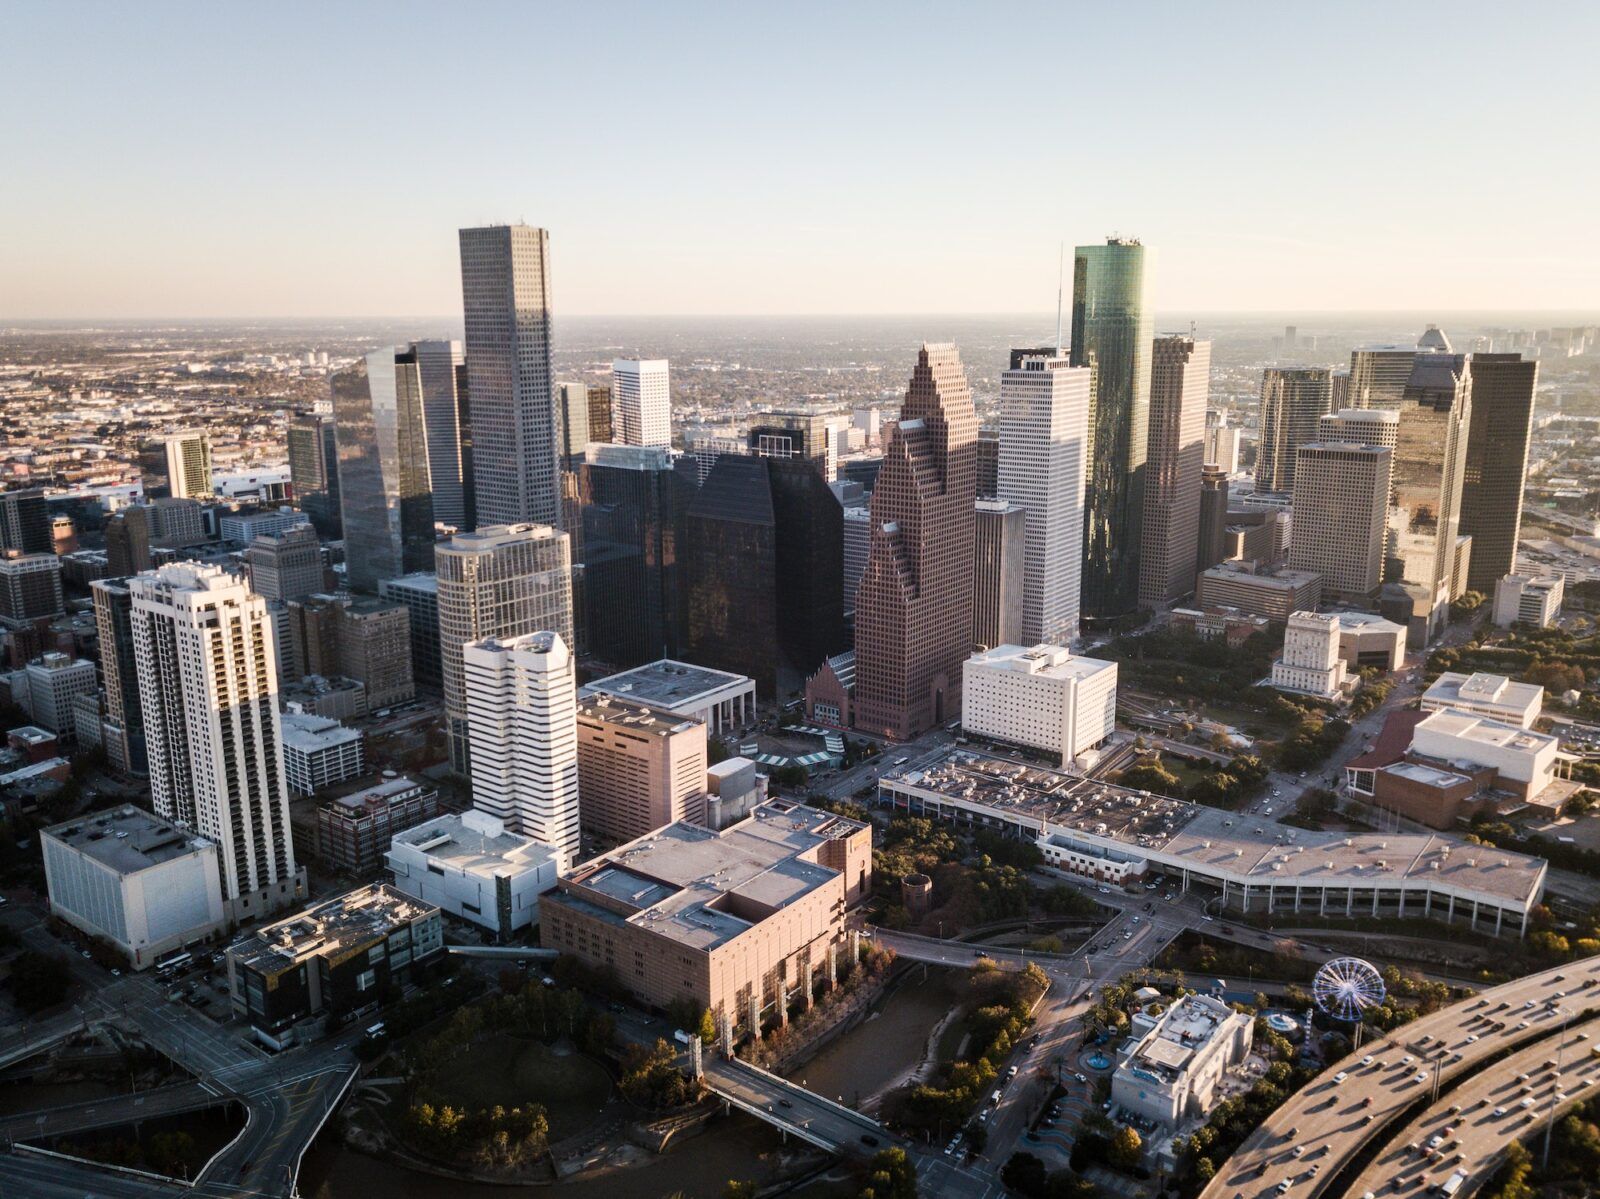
[1384,354,1472,645]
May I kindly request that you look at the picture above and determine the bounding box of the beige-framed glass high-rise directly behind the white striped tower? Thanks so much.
[434,525,573,773]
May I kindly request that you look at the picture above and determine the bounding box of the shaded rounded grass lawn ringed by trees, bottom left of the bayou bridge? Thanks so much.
[427,1033,611,1141]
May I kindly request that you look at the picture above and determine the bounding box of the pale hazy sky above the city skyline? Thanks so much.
[0,0,1600,319]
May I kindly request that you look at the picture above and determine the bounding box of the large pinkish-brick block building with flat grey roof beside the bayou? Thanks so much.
[542,800,872,1033]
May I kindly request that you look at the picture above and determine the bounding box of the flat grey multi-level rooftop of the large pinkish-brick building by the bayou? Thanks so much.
[552,800,866,952]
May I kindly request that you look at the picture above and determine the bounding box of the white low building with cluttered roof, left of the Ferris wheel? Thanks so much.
[1110,994,1256,1130]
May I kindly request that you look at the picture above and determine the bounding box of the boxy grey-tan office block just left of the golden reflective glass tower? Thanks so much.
[1290,442,1394,602]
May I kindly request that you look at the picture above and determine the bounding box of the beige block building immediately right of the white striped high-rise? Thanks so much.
[578,695,706,840]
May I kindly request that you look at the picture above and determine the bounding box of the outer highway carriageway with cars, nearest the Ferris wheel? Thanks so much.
[1202,959,1600,1199]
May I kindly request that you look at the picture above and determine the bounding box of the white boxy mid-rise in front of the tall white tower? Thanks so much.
[962,645,1117,765]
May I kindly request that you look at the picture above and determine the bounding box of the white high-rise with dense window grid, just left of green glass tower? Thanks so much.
[982,349,1093,645]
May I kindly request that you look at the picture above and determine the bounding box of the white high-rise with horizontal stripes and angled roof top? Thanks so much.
[462,629,578,871]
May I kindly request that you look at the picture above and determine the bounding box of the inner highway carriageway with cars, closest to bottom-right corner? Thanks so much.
[1347,1018,1600,1199]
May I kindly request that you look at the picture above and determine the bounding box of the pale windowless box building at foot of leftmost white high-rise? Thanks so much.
[38,805,227,970]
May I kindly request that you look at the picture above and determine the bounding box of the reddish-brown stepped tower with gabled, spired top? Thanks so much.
[854,346,978,741]
